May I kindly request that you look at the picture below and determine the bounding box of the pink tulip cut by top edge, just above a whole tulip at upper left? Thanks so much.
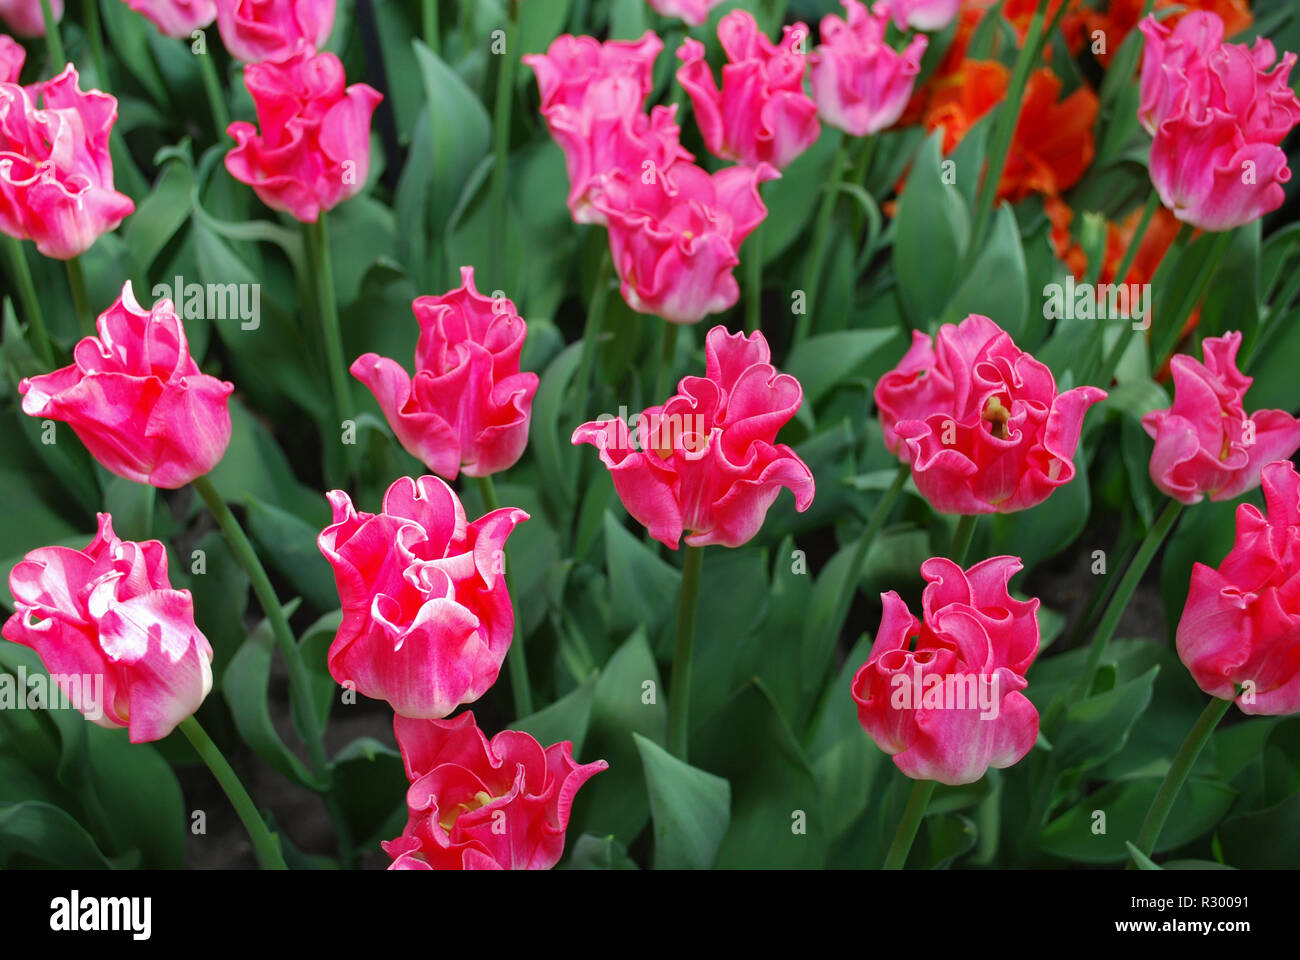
[216,0,334,64]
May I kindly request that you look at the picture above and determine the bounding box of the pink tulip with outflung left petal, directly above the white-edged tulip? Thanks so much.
[352,267,537,480]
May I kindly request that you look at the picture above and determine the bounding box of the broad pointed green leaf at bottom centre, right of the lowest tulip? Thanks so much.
[633,734,731,870]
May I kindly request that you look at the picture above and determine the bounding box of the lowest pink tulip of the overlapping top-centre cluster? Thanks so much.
[597,161,780,324]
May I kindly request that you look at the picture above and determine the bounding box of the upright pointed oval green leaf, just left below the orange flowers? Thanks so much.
[893,130,970,329]
